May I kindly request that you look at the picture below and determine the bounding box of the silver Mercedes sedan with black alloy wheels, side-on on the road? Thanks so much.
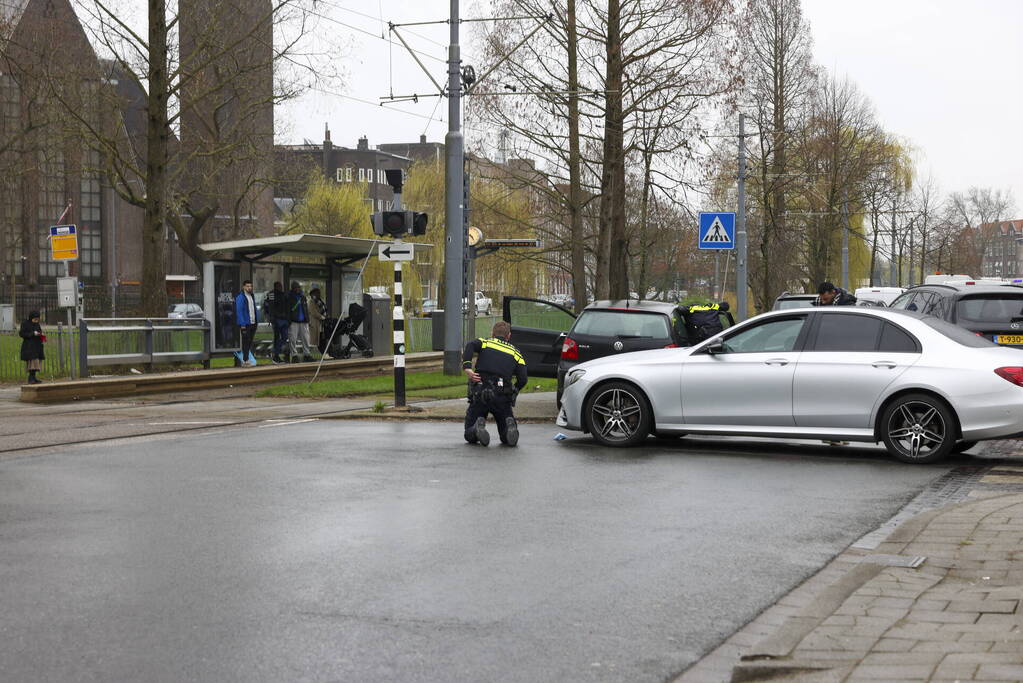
[558,307,1023,462]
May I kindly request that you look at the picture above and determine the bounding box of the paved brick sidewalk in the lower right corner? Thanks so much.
[677,449,1023,683]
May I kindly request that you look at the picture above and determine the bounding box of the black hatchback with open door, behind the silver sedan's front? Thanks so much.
[504,297,735,400]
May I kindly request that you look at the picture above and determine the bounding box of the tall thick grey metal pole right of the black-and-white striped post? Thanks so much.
[444,0,468,375]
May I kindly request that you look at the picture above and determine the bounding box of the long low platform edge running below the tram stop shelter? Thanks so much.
[21,352,444,403]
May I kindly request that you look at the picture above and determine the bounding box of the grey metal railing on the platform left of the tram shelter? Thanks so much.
[78,318,211,377]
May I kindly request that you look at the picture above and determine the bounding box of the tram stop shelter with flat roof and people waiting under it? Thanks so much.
[199,234,421,356]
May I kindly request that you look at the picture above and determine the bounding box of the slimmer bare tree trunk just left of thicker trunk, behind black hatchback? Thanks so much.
[567,0,586,312]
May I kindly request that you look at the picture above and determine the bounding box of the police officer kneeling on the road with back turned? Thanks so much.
[461,321,529,446]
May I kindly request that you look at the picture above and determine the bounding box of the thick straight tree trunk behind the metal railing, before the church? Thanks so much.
[142,0,169,316]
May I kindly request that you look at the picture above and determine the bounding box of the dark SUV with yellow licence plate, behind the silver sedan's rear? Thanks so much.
[889,281,1023,349]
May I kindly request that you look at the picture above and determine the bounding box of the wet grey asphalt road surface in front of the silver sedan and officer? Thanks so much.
[0,421,948,681]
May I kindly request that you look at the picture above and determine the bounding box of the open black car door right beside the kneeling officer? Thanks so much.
[504,297,576,377]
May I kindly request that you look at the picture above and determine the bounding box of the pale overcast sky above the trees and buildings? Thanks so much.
[278,0,1023,213]
